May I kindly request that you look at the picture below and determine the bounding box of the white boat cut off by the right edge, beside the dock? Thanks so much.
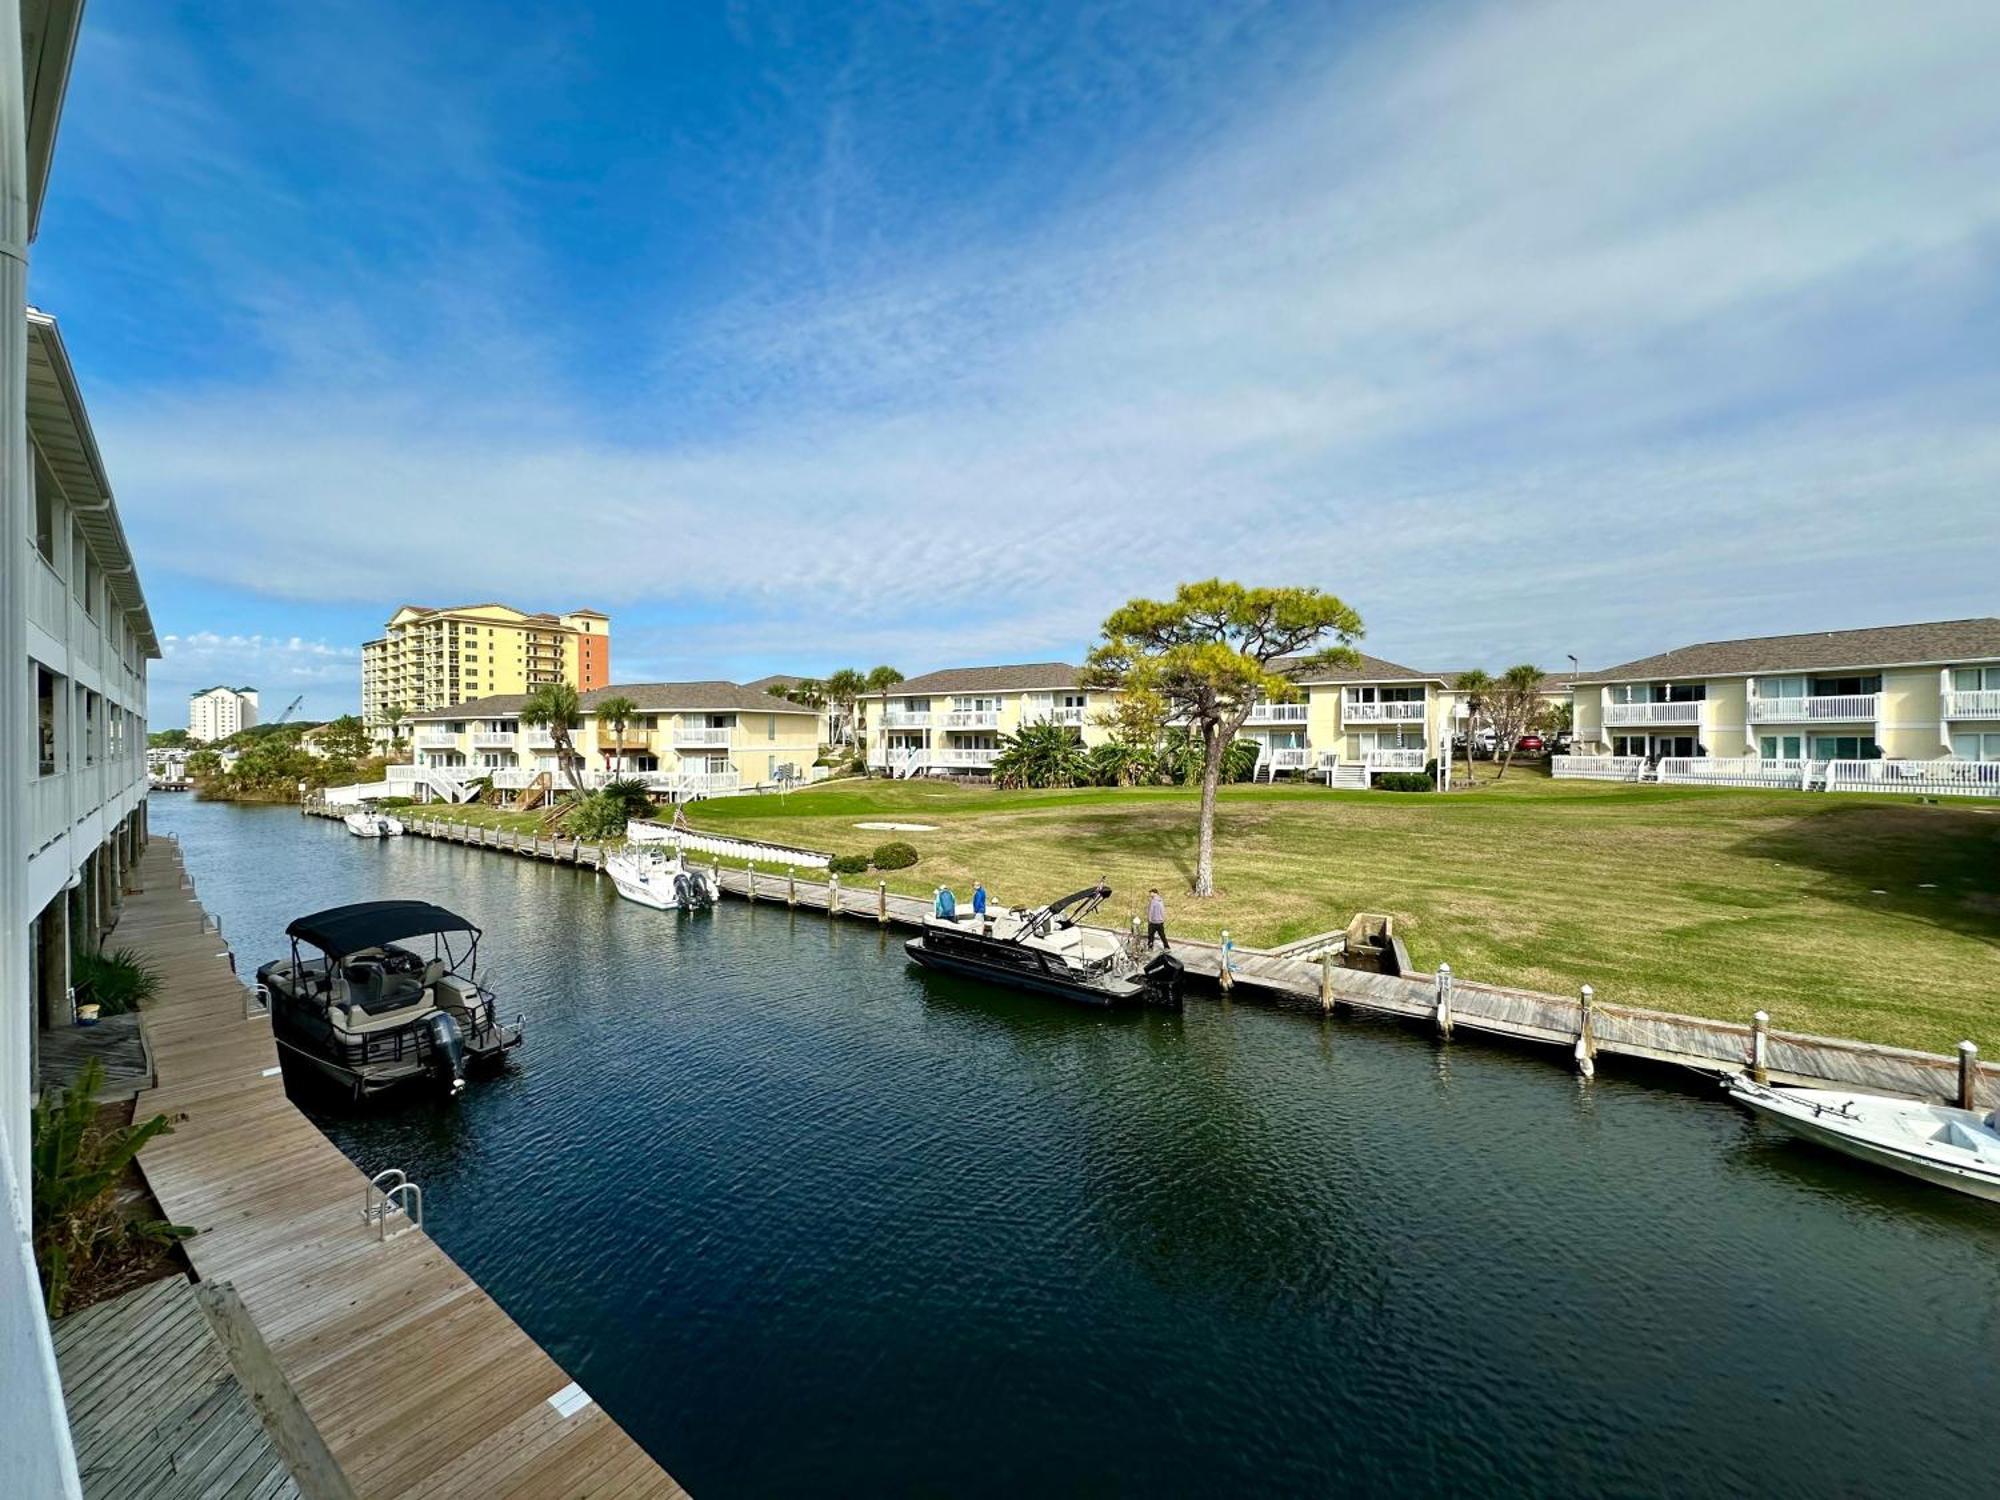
[1722,1074,2000,1202]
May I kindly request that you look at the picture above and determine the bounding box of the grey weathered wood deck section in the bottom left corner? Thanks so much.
[54,1276,298,1500]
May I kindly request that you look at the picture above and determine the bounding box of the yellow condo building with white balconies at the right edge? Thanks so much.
[1576,618,2000,790]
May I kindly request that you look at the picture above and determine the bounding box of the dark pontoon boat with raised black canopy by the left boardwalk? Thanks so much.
[256,900,520,1100]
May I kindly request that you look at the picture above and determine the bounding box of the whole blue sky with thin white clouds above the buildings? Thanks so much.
[30,0,2000,724]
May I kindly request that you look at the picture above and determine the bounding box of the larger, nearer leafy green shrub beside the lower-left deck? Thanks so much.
[28,1058,194,1318]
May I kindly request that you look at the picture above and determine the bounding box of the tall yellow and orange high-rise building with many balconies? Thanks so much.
[362,604,612,730]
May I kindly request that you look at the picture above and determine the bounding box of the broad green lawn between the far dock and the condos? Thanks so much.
[688,766,2000,1052]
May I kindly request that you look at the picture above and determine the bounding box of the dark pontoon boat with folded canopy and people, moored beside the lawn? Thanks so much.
[904,884,1182,1008]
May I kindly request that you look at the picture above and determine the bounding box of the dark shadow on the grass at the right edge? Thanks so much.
[1730,802,2000,946]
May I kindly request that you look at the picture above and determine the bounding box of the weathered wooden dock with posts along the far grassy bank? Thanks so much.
[336,808,2000,1108]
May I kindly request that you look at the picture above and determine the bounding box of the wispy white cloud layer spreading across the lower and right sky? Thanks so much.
[66,0,2000,668]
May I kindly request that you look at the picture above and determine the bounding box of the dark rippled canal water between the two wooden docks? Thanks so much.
[154,796,2000,1498]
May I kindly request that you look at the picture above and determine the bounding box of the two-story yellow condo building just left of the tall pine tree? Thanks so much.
[856,662,1114,776]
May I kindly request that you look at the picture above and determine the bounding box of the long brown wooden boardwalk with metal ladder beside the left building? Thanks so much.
[118,836,684,1500]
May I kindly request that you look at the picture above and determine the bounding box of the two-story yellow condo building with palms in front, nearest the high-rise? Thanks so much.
[402,682,822,800]
